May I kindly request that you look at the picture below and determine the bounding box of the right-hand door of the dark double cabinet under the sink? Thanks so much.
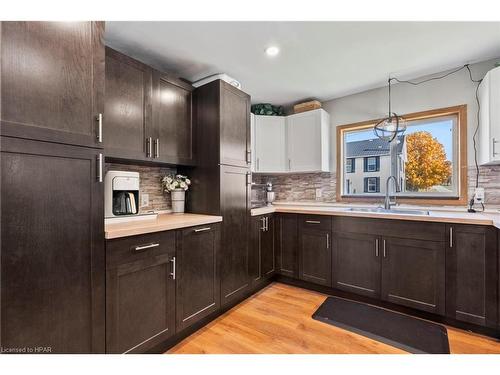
[381,237,445,315]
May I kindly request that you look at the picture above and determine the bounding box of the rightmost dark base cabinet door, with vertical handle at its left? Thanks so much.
[446,225,498,327]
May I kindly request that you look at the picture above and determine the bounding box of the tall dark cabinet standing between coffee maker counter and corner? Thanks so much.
[187,80,251,305]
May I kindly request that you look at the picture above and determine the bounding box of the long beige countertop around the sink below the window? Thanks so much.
[251,202,500,229]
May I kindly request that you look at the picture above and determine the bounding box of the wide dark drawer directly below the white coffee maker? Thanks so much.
[106,231,175,268]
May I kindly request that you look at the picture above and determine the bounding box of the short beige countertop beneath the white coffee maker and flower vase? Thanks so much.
[104,213,222,240]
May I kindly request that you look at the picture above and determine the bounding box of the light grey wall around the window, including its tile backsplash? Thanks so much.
[258,58,500,208]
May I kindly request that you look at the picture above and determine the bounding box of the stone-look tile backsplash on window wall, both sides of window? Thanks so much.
[253,165,500,209]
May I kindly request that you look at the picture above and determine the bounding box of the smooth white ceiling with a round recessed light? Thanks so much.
[105,22,500,104]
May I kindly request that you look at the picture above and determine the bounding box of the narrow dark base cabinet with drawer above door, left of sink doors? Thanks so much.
[299,215,332,286]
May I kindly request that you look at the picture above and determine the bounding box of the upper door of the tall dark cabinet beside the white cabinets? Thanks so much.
[220,81,250,167]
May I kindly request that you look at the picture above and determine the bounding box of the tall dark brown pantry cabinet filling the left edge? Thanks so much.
[0,22,105,353]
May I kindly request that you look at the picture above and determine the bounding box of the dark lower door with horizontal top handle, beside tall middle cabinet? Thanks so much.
[176,224,220,331]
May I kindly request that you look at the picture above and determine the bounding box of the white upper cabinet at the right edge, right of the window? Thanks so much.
[478,67,500,165]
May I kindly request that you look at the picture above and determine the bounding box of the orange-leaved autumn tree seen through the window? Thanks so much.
[406,131,451,191]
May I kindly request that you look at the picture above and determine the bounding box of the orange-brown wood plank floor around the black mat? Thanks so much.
[167,283,500,354]
